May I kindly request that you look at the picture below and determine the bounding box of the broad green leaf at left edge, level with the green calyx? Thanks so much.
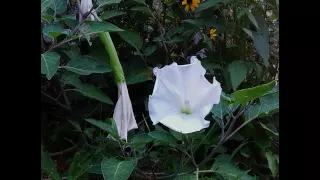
[41,52,60,80]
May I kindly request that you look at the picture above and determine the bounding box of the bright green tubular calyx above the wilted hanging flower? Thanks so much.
[99,32,126,84]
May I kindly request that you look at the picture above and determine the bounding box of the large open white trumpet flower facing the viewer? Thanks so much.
[148,56,221,133]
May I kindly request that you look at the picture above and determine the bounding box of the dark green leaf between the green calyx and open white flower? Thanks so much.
[126,68,152,85]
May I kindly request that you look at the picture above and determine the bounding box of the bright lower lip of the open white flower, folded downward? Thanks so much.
[160,113,210,134]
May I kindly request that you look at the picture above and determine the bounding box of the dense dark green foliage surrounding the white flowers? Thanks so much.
[41,0,279,180]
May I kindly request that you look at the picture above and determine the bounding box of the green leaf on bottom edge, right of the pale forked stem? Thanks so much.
[211,154,255,180]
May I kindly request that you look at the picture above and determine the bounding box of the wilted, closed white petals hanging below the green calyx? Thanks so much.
[113,83,138,140]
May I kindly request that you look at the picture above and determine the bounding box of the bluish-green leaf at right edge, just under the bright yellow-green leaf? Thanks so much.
[245,93,279,121]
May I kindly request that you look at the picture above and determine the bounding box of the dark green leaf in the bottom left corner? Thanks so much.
[41,148,61,180]
